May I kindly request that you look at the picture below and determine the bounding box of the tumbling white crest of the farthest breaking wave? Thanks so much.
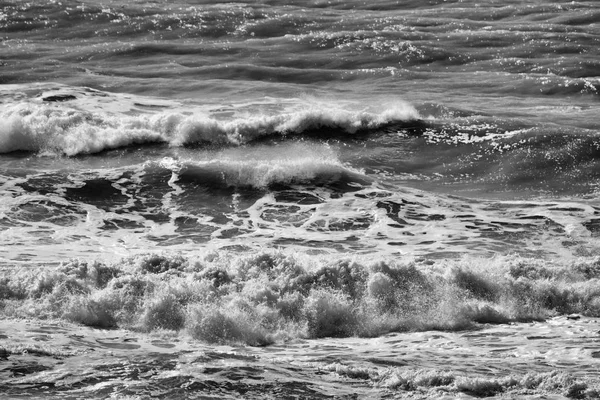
[0,102,419,156]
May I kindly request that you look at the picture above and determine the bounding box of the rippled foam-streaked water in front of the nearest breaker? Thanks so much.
[0,314,600,399]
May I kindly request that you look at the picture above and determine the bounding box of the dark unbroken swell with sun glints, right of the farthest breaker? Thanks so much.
[392,116,600,197]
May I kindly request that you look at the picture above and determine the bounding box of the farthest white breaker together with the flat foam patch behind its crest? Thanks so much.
[0,85,419,156]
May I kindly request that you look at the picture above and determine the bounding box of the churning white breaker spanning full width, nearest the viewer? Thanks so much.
[0,251,600,346]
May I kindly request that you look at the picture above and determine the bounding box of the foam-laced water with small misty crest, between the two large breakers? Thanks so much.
[0,155,598,264]
